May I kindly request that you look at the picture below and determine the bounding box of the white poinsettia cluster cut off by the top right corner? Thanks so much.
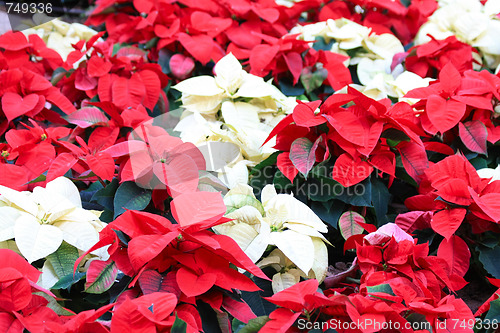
[415,0,500,68]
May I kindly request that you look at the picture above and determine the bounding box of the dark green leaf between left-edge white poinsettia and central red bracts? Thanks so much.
[113,182,151,219]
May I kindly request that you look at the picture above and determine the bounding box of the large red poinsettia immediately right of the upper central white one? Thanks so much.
[268,88,427,187]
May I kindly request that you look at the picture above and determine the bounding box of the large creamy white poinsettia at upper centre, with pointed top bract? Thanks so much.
[173,53,296,188]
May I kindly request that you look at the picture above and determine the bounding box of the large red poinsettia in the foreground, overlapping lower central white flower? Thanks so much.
[75,192,267,332]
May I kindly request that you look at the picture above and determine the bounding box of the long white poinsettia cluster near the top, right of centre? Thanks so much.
[291,18,431,103]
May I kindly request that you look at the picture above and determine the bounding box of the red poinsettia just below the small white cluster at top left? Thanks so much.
[58,39,168,114]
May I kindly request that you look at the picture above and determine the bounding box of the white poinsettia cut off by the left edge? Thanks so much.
[0,177,106,263]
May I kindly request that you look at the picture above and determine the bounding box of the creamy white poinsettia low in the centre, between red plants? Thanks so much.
[214,184,330,292]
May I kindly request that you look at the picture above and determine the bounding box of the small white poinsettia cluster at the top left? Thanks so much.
[22,19,101,67]
